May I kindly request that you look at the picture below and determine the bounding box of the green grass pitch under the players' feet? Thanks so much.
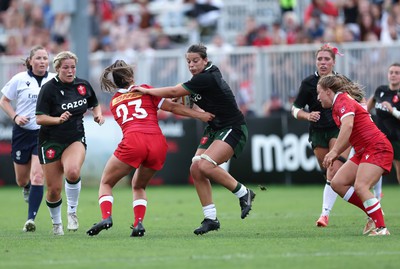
[0,185,400,269]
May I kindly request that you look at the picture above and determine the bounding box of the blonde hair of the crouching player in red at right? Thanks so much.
[318,75,365,102]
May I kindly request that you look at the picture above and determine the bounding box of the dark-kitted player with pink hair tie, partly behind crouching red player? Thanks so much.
[292,44,350,227]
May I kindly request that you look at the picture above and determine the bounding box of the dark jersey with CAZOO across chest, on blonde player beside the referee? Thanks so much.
[36,76,98,143]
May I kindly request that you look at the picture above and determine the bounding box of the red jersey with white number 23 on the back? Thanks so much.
[110,85,164,136]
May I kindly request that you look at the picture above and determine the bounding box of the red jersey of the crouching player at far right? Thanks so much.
[332,92,386,153]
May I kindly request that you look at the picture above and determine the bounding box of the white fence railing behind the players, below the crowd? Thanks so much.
[0,43,400,117]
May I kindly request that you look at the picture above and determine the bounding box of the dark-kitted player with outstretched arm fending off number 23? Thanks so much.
[134,44,255,235]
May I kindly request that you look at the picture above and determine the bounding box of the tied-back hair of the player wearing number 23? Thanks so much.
[100,60,135,93]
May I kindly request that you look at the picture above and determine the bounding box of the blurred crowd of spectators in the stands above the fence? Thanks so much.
[0,0,400,55]
